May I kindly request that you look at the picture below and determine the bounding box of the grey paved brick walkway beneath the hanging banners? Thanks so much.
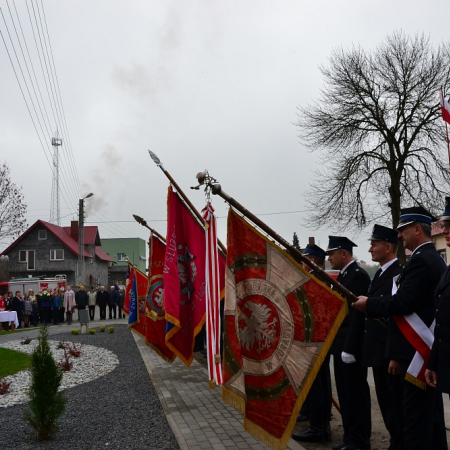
[133,333,304,450]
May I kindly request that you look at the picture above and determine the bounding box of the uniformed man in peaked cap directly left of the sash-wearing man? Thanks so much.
[363,225,404,450]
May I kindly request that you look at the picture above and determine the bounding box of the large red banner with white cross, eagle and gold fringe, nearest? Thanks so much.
[222,209,348,449]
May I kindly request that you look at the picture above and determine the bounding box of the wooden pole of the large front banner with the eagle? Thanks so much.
[211,184,358,302]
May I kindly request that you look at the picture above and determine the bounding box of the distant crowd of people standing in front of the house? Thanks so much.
[0,285,125,330]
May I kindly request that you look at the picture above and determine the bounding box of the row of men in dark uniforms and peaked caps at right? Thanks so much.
[293,197,450,450]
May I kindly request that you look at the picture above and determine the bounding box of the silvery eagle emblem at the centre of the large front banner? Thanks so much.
[239,301,277,354]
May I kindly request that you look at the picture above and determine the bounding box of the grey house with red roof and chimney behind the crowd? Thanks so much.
[1,220,114,287]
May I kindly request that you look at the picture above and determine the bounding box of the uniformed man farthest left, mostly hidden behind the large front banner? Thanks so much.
[292,244,331,442]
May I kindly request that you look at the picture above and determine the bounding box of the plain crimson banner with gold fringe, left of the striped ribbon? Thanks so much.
[163,187,206,366]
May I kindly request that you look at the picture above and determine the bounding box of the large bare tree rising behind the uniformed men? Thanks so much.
[297,32,450,234]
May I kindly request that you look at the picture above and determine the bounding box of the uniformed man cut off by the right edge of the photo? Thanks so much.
[425,197,450,394]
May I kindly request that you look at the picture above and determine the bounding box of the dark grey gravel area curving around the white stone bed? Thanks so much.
[0,325,179,450]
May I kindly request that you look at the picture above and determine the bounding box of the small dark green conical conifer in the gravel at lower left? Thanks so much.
[23,326,67,441]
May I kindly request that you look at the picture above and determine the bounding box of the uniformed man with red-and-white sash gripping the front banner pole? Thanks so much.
[353,207,447,450]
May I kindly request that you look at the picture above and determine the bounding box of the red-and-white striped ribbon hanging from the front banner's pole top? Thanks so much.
[202,202,225,387]
